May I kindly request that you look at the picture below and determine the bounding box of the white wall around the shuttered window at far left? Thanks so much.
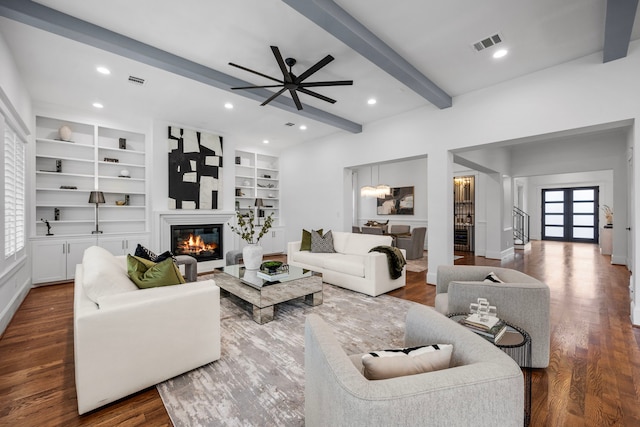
[0,35,34,335]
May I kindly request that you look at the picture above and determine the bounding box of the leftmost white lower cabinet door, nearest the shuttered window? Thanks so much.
[31,240,67,283]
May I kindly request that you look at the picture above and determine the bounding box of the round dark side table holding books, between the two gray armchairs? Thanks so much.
[447,313,531,426]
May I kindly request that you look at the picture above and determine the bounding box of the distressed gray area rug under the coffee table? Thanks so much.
[157,282,415,426]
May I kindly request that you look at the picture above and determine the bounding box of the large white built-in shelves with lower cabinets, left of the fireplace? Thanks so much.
[31,116,149,283]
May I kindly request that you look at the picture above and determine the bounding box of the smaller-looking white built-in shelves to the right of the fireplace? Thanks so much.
[235,151,280,225]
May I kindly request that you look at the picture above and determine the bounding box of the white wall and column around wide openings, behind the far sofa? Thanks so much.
[281,42,640,310]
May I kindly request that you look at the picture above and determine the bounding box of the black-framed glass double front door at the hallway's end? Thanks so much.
[542,187,598,243]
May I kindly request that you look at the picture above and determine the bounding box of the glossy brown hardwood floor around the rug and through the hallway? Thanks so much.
[0,242,640,426]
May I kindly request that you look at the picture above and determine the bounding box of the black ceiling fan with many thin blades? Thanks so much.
[229,46,353,110]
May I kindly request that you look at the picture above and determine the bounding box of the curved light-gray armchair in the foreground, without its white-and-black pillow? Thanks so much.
[304,305,524,427]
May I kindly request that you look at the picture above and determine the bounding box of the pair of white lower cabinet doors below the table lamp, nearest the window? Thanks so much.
[31,237,96,284]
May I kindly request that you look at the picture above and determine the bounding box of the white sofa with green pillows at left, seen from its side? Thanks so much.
[73,246,220,414]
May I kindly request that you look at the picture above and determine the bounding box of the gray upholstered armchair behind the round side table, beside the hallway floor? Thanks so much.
[435,265,551,368]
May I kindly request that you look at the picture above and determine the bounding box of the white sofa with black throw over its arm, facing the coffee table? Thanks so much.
[287,231,406,296]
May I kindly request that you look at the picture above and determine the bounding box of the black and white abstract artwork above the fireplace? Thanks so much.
[169,126,222,209]
